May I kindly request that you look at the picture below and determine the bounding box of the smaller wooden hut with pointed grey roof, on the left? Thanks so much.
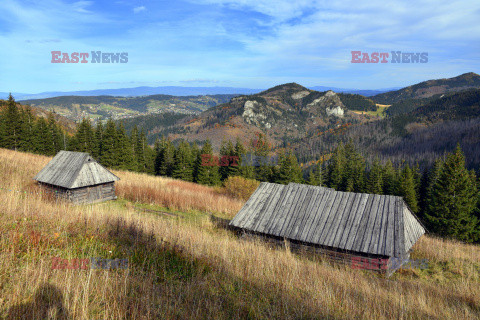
[34,151,120,203]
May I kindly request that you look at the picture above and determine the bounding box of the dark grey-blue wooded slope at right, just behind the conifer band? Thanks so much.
[291,89,480,170]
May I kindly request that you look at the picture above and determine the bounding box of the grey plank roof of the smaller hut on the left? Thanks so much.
[34,151,120,189]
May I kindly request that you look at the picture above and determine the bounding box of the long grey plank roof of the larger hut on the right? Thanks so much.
[230,182,425,257]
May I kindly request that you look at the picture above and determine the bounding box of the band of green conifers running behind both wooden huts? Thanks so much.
[0,95,480,242]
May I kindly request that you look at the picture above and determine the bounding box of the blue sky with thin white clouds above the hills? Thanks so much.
[0,0,480,93]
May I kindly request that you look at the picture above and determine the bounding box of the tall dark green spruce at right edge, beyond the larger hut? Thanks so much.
[426,145,480,242]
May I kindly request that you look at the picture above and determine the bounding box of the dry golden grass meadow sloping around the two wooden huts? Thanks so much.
[0,149,480,319]
